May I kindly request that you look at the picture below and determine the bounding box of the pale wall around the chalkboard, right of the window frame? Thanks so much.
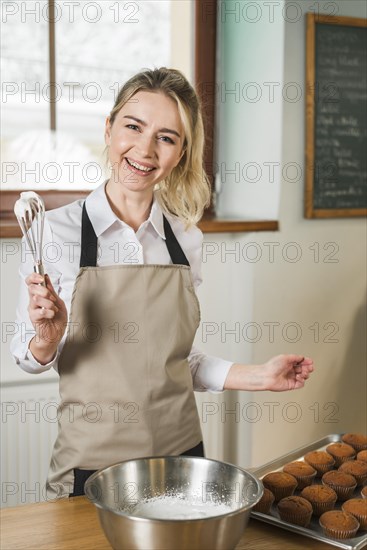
[203,1,367,466]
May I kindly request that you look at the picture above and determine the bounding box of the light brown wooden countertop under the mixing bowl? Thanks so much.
[0,497,335,550]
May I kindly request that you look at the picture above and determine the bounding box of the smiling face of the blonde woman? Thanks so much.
[105,91,185,198]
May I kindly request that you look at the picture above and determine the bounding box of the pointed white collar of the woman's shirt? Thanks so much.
[86,181,166,239]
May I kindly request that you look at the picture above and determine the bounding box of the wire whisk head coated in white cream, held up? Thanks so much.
[14,191,45,284]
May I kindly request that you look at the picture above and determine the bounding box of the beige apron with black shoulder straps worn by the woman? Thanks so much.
[47,206,202,498]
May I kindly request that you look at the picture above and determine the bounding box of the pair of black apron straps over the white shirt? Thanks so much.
[80,201,190,267]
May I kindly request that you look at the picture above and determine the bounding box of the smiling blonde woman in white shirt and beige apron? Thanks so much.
[12,68,313,497]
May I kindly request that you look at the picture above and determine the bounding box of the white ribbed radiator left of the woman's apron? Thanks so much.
[1,382,59,507]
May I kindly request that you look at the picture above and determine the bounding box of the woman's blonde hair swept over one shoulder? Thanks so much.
[110,67,211,227]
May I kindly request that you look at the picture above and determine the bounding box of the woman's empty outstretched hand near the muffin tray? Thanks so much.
[263,355,313,391]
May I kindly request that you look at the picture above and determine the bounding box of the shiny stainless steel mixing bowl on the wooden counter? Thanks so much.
[85,456,263,550]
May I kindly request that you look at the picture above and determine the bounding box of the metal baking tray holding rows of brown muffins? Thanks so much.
[251,434,367,550]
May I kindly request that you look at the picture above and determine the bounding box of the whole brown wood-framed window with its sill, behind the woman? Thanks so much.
[0,0,270,237]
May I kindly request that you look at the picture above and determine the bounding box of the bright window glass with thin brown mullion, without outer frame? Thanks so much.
[2,0,173,194]
